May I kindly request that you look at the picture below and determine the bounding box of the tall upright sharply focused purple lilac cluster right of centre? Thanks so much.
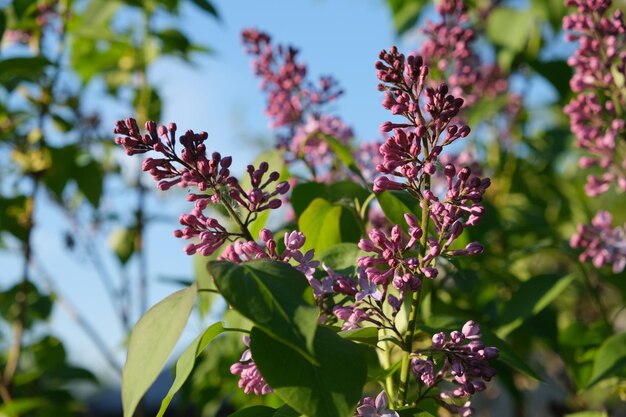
[374,48,490,264]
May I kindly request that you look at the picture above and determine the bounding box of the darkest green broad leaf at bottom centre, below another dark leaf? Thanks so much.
[250,327,367,417]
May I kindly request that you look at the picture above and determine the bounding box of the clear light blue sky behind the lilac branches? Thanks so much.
[0,0,424,377]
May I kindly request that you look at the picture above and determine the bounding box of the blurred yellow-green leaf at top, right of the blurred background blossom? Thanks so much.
[487,7,533,52]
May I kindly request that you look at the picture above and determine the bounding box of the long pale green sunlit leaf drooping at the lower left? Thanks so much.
[122,283,198,417]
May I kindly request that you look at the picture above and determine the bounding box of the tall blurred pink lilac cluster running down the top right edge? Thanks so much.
[563,0,626,197]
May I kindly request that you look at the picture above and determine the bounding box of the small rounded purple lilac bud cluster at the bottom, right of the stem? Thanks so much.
[411,320,499,416]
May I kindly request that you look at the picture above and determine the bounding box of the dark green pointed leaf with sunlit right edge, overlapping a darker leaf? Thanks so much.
[208,259,318,360]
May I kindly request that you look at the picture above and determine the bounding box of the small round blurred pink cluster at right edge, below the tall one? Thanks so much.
[570,210,626,274]
